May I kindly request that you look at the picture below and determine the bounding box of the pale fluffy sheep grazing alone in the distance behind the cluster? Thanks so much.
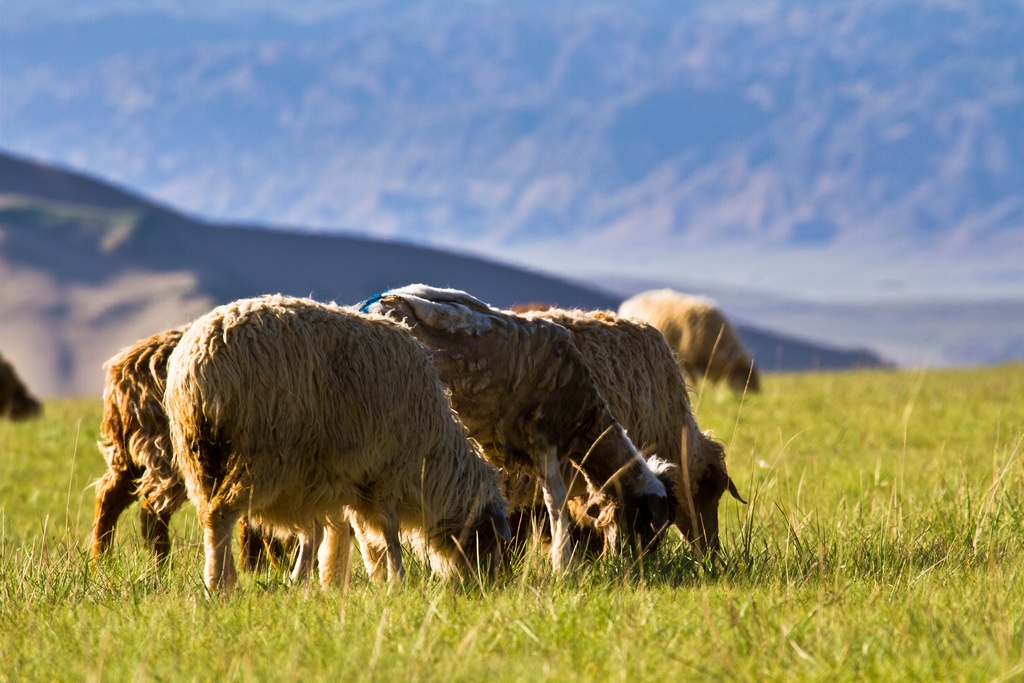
[618,289,761,392]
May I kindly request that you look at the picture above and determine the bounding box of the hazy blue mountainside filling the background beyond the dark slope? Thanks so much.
[0,0,1024,302]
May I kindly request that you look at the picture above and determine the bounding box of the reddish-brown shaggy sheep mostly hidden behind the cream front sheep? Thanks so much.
[91,326,303,579]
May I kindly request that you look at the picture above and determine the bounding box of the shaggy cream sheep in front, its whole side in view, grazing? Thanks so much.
[164,295,510,591]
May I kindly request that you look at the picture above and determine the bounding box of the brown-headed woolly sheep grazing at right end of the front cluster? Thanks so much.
[523,308,745,554]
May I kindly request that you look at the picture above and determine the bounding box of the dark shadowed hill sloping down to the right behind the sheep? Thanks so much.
[0,149,881,396]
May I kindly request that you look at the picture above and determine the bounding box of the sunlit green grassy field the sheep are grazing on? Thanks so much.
[0,365,1024,681]
